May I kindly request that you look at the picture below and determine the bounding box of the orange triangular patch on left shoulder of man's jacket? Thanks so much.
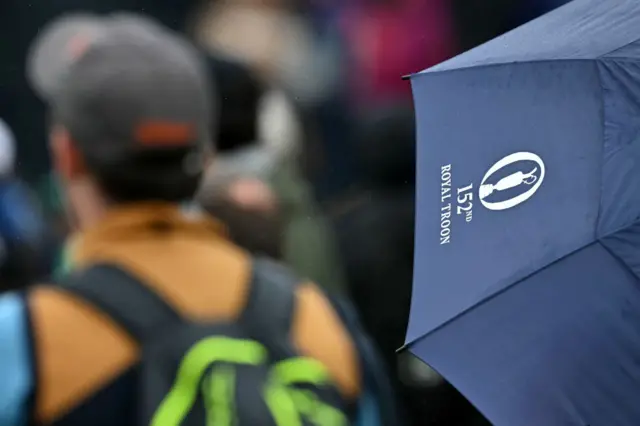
[28,285,138,424]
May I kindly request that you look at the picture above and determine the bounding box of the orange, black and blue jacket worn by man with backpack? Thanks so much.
[0,204,390,426]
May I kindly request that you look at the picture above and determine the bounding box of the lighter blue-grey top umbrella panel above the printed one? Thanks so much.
[424,0,640,73]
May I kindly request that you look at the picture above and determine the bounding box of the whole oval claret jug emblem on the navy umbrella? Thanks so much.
[478,152,545,210]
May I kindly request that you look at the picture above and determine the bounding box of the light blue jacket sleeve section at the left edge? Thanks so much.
[0,293,33,426]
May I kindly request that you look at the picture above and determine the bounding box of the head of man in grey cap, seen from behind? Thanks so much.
[28,14,214,228]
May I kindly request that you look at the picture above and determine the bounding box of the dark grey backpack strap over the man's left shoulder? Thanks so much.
[59,264,183,343]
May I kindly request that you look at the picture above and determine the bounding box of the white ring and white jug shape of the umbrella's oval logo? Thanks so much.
[478,152,545,210]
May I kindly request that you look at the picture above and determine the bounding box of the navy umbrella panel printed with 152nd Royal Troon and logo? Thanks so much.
[407,61,603,342]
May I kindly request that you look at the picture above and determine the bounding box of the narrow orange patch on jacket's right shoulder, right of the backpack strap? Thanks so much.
[292,283,362,399]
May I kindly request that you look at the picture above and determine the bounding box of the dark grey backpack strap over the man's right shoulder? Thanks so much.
[240,257,300,341]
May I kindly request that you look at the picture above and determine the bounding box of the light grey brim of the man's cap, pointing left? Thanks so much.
[27,13,104,100]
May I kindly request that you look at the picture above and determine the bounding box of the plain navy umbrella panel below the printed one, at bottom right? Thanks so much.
[411,243,640,426]
